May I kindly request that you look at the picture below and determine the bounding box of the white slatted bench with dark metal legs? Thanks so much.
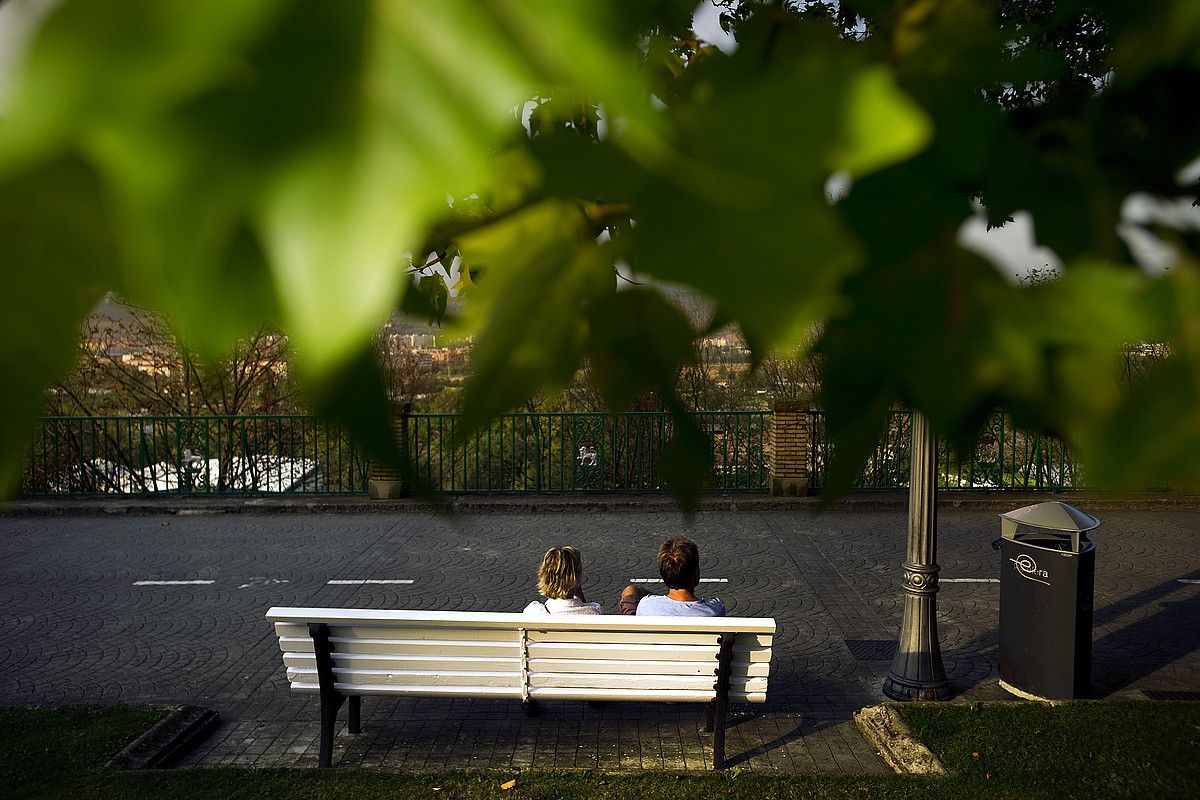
[266,607,775,769]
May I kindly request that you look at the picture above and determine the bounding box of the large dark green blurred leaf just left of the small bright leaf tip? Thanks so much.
[614,20,899,357]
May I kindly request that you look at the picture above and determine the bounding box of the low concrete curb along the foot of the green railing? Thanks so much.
[0,492,1200,517]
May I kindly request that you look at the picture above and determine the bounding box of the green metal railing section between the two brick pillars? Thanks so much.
[408,411,770,493]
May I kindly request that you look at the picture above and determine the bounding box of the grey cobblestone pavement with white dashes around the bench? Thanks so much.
[0,504,1200,772]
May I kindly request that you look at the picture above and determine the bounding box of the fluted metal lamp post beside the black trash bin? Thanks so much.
[883,411,950,700]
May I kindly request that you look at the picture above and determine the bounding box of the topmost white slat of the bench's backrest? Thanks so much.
[266,607,775,633]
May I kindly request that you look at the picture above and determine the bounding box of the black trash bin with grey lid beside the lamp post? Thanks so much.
[1000,503,1100,700]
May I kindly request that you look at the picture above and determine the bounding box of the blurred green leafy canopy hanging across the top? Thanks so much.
[0,0,1200,497]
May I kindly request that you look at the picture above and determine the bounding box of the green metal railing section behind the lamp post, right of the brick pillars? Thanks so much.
[809,410,1082,492]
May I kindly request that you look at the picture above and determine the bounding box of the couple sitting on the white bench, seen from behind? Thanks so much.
[524,537,725,616]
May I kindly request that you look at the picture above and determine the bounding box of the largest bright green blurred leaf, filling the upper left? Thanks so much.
[0,0,653,453]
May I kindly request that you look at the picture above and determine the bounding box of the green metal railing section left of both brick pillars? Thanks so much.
[22,415,367,494]
